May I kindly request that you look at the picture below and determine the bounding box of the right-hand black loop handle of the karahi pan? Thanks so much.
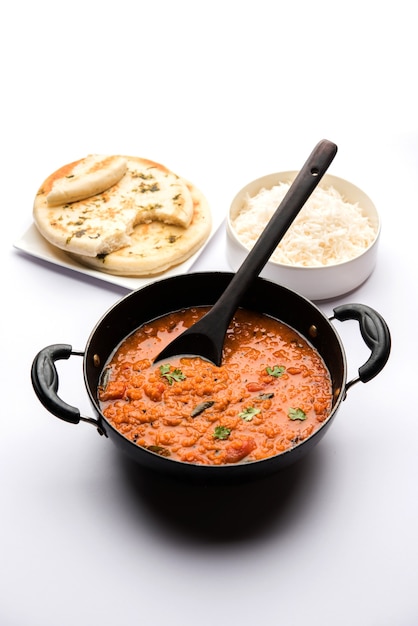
[331,303,391,389]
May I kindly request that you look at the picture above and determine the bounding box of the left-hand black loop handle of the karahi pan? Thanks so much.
[31,343,105,435]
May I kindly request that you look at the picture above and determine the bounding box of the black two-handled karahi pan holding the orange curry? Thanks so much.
[31,272,391,483]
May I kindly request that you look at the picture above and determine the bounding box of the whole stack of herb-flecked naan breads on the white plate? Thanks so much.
[33,155,212,276]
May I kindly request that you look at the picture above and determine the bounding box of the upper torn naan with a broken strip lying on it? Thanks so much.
[33,155,194,258]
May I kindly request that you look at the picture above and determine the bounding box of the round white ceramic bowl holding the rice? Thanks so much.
[226,171,381,300]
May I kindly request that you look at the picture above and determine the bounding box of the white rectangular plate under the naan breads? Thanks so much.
[14,217,222,290]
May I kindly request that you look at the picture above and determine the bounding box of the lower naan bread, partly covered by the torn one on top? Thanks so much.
[71,183,212,277]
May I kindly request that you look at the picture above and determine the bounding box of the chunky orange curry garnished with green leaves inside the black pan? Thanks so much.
[98,307,332,465]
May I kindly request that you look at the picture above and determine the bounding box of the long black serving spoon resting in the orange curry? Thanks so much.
[154,139,337,366]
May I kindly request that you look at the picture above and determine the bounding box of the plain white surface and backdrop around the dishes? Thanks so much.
[0,0,418,626]
